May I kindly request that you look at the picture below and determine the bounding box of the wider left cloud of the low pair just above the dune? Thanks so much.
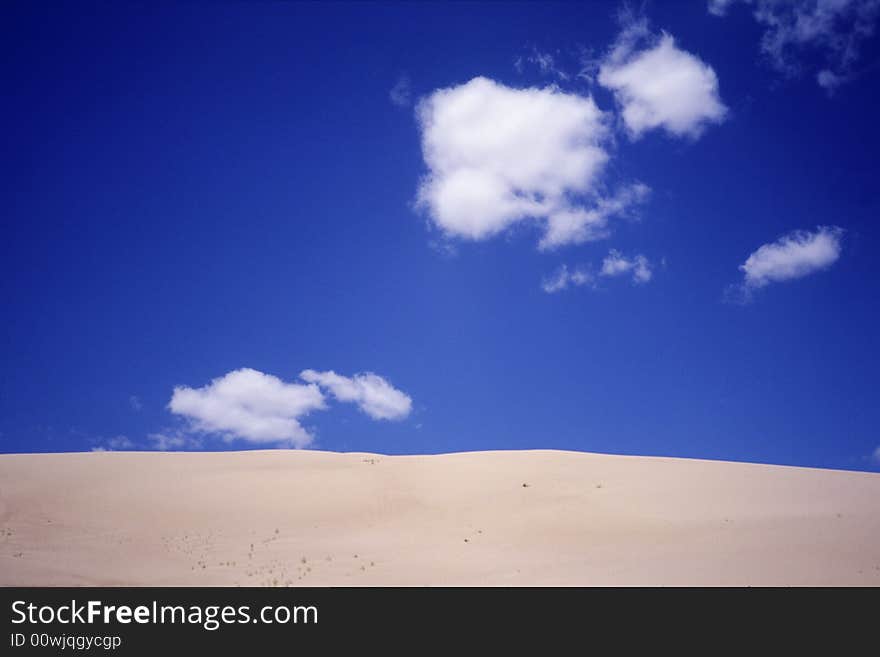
[168,368,325,448]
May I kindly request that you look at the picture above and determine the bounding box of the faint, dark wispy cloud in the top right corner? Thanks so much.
[708,0,880,93]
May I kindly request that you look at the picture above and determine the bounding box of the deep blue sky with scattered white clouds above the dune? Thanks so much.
[0,0,880,469]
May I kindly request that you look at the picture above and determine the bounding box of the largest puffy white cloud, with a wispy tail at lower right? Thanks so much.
[417,77,647,249]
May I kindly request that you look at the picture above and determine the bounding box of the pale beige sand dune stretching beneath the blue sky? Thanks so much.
[0,450,880,586]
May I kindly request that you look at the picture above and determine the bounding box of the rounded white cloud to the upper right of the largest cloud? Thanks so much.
[598,19,727,138]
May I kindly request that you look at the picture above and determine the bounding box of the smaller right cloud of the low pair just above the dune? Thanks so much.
[300,370,412,420]
